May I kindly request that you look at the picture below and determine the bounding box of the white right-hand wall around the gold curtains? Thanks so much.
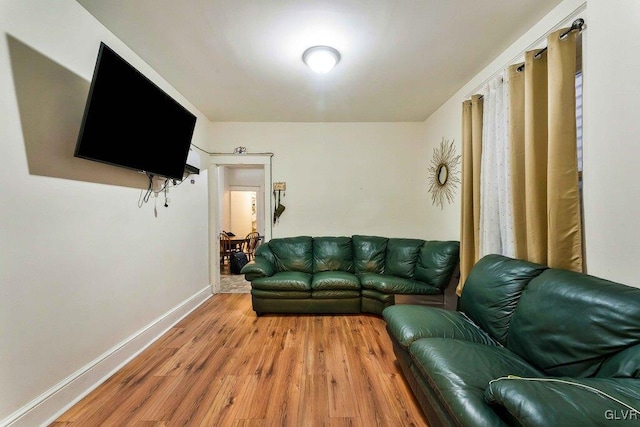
[426,0,640,286]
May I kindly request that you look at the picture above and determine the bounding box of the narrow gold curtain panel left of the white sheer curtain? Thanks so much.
[456,95,483,295]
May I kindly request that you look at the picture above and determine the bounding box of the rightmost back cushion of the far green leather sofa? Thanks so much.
[414,241,460,289]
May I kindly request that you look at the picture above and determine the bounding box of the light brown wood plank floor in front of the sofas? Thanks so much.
[52,294,426,426]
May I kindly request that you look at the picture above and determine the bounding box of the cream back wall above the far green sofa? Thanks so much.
[210,123,444,239]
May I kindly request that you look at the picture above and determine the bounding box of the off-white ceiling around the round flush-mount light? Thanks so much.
[77,0,561,122]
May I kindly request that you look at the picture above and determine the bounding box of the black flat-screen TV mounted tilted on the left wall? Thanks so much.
[75,43,196,179]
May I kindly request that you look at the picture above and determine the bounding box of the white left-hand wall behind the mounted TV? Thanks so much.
[0,0,209,425]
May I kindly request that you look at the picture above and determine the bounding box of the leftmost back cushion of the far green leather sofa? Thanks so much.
[269,236,313,273]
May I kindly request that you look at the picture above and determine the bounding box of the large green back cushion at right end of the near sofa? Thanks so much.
[507,269,640,377]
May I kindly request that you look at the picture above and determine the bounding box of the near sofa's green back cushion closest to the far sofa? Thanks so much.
[458,255,547,345]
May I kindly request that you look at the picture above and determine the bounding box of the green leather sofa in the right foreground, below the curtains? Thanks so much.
[383,255,640,427]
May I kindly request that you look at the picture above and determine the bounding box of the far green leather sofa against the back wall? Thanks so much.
[241,235,460,315]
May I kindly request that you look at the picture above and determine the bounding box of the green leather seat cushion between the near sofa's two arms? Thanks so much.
[409,338,543,426]
